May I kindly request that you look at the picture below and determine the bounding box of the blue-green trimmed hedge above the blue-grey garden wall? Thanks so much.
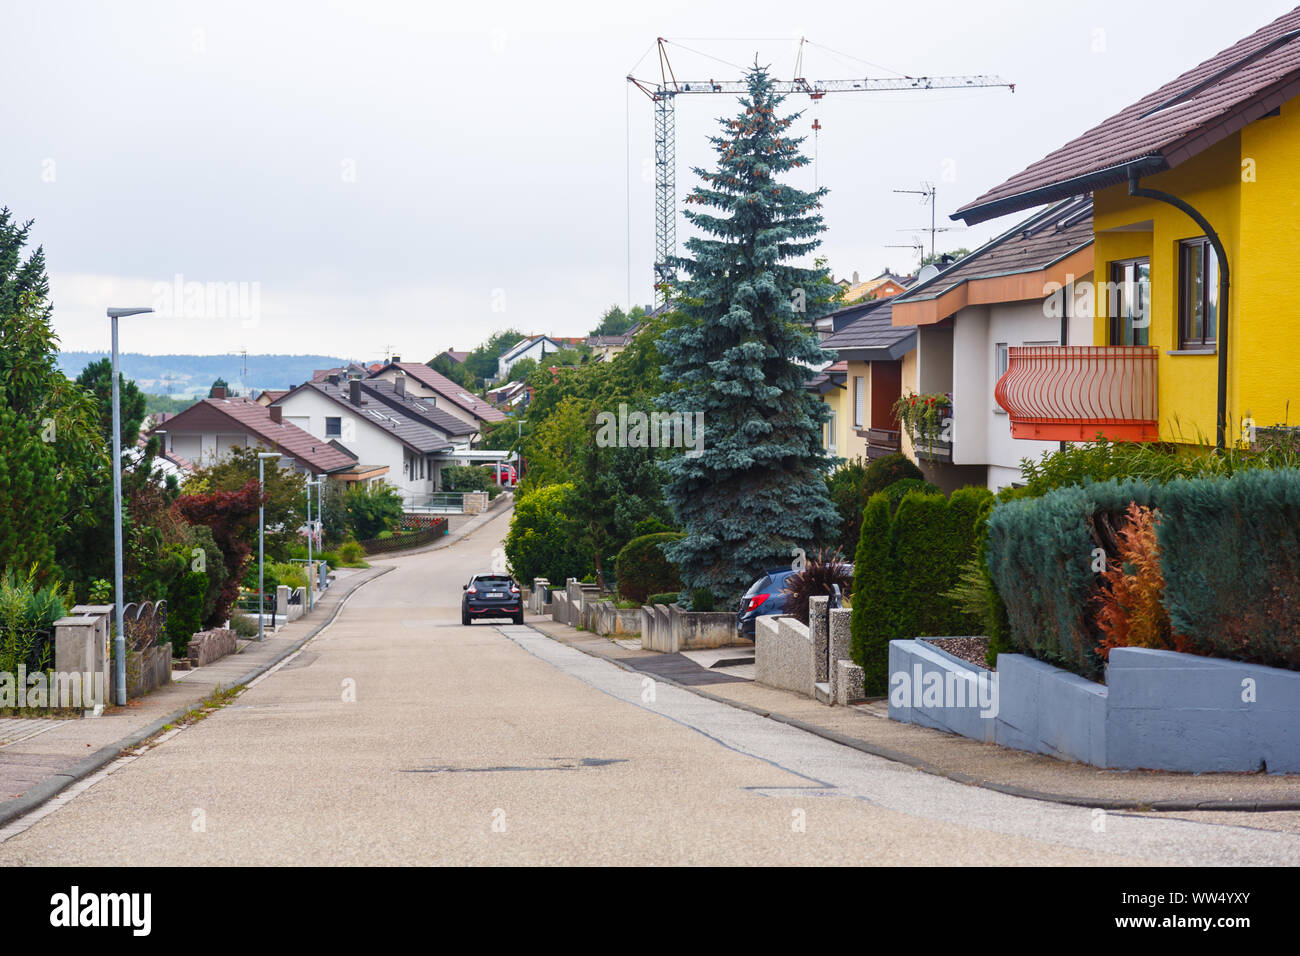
[987,468,1300,680]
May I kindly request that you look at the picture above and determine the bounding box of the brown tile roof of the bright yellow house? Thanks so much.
[953,8,1300,222]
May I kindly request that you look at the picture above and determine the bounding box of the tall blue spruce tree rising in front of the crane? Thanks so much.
[659,64,839,601]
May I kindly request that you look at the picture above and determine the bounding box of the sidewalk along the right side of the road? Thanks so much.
[524,614,1300,825]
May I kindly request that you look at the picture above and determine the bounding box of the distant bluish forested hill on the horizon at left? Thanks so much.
[59,351,352,398]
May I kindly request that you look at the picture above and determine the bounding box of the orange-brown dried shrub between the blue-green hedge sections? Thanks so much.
[1096,502,1187,658]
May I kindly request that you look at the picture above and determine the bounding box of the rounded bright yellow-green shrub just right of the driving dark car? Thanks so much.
[506,484,594,587]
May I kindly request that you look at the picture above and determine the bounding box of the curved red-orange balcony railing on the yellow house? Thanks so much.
[993,345,1160,441]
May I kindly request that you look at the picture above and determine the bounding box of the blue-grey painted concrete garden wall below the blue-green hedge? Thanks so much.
[889,639,1300,773]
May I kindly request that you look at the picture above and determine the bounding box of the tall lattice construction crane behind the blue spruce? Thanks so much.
[628,36,1015,304]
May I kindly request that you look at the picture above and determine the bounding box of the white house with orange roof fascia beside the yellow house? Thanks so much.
[892,196,1093,490]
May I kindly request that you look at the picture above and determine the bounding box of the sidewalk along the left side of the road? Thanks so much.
[0,567,393,827]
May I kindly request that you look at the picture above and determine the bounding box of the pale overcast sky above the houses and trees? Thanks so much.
[0,0,1294,360]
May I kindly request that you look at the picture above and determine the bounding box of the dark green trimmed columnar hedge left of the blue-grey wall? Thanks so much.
[850,488,992,695]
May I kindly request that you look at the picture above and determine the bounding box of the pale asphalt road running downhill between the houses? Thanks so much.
[0,515,1300,866]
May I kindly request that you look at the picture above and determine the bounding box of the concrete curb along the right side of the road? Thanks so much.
[525,622,1300,813]
